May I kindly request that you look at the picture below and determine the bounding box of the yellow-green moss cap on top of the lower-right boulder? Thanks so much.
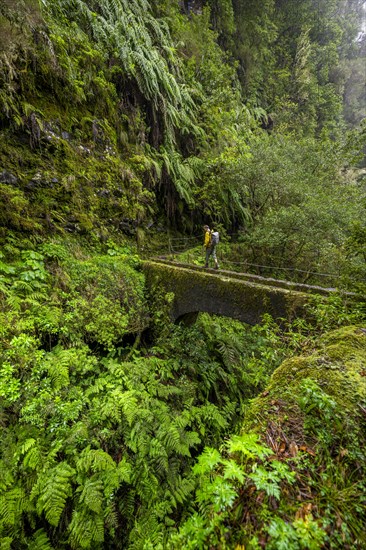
[244,326,366,438]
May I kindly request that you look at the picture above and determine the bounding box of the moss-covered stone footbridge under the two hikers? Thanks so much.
[143,259,337,325]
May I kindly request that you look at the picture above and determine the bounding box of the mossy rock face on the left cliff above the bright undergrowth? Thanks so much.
[0,132,154,242]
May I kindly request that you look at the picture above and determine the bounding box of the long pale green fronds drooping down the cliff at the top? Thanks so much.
[45,0,200,137]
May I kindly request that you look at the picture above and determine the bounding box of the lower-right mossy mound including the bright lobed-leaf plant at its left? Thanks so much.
[170,326,366,550]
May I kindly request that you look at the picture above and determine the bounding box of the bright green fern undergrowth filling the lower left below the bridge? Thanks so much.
[0,236,288,549]
